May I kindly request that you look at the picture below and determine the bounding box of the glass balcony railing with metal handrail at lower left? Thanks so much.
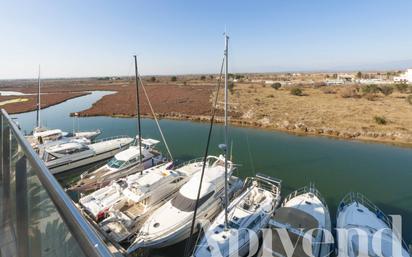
[0,110,113,257]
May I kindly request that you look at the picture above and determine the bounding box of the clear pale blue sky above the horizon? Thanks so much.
[0,0,412,79]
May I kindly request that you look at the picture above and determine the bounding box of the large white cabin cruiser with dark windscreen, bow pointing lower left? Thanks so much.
[127,155,243,253]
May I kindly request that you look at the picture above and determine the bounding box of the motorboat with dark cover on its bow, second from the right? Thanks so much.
[258,185,333,257]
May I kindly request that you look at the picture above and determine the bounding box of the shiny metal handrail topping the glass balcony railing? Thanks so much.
[1,109,113,257]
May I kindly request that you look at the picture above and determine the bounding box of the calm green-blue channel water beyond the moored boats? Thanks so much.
[13,92,412,249]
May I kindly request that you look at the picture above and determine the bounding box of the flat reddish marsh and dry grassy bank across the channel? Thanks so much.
[0,76,412,147]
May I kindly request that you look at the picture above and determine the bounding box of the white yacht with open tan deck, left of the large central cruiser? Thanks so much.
[99,158,204,243]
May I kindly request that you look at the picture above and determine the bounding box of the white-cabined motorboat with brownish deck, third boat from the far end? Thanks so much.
[69,139,166,193]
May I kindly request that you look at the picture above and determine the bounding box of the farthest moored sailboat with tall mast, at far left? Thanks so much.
[26,66,101,150]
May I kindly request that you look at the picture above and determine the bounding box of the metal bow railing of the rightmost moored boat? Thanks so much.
[337,192,409,250]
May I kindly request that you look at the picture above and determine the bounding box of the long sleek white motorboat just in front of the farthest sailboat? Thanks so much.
[39,136,133,174]
